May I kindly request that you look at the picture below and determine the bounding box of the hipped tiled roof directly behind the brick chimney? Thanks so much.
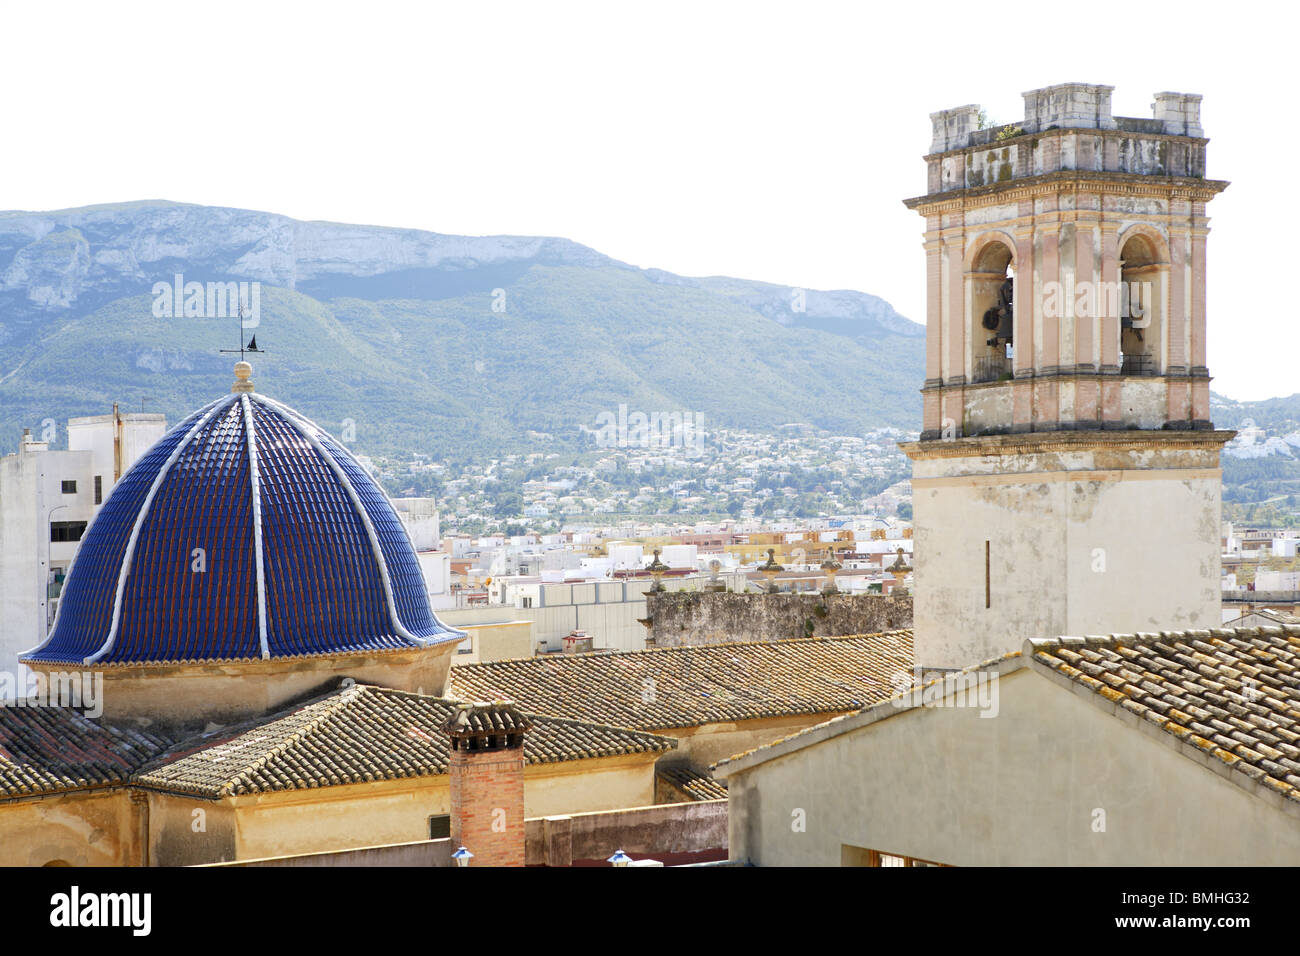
[135,684,676,799]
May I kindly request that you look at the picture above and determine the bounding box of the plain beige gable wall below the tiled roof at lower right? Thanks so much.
[728,669,1300,866]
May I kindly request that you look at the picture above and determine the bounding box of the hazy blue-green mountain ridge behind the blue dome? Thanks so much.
[0,200,924,454]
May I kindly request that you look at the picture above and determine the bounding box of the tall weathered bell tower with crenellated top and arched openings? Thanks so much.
[901,83,1232,667]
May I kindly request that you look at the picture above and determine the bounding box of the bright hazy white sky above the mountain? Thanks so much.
[0,0,1300,398]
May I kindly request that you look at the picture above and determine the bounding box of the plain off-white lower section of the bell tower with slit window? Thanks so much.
[913,446,1222,667]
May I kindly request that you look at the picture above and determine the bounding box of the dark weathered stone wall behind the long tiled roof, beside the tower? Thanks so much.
[646,591,911,648]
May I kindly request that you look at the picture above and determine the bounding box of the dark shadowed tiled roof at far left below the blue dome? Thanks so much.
[0,705,170,797]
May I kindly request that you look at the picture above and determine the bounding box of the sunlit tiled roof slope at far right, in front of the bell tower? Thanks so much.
[1030,626,1300,803]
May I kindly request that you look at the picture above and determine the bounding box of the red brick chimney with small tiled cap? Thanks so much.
[442,701,532,866]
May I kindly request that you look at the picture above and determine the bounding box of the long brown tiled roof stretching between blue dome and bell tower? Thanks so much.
[451,631,913,730]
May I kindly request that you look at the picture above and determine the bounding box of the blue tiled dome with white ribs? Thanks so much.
[25,382,464,665]
